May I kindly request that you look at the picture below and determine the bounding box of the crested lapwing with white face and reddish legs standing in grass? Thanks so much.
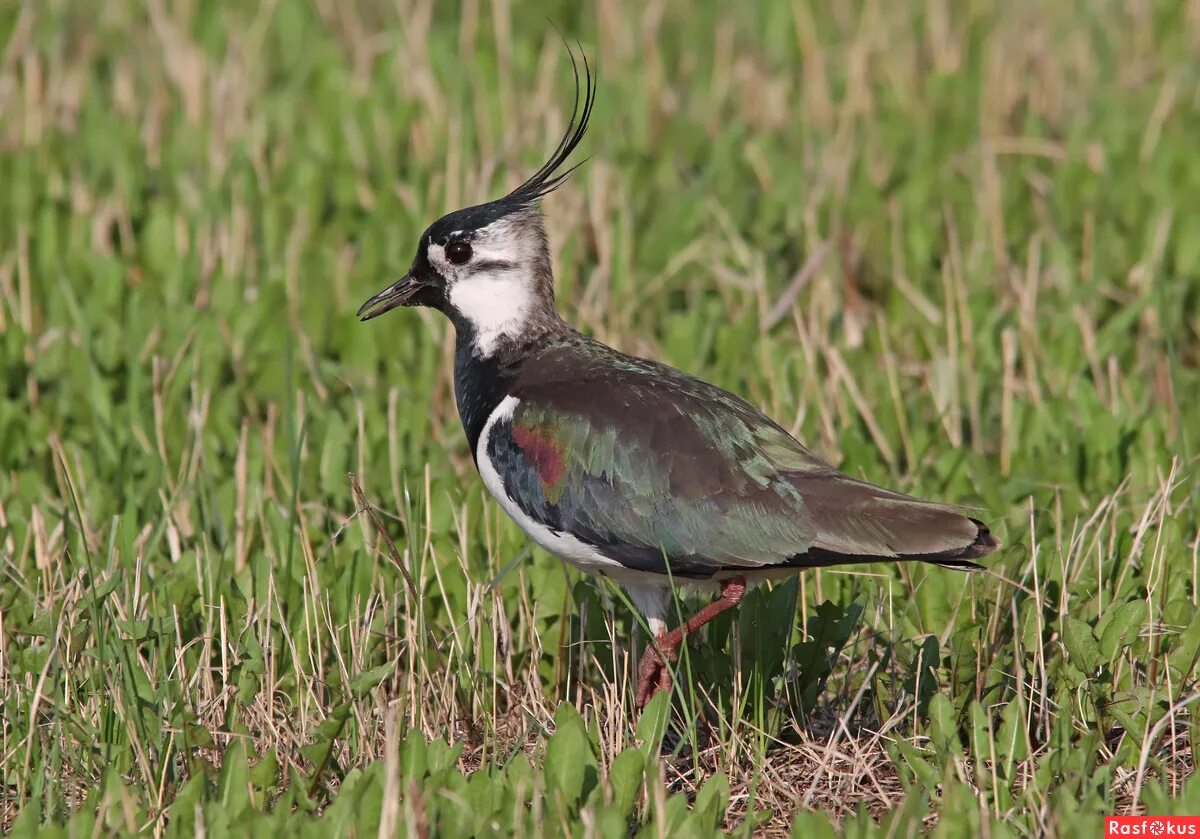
[358,47,1001,708]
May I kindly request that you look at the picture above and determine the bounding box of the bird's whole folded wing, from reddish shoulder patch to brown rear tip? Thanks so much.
[488,343,998,576]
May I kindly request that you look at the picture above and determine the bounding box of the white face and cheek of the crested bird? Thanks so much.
[427,217,544,358]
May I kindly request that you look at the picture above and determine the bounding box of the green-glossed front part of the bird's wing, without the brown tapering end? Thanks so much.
[488,345,832,576]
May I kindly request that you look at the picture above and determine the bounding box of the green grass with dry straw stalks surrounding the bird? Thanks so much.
[0,0,1200,837]
